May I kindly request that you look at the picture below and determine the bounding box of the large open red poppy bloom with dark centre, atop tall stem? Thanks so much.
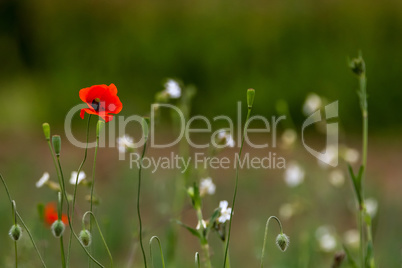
[80,84,123,122]
